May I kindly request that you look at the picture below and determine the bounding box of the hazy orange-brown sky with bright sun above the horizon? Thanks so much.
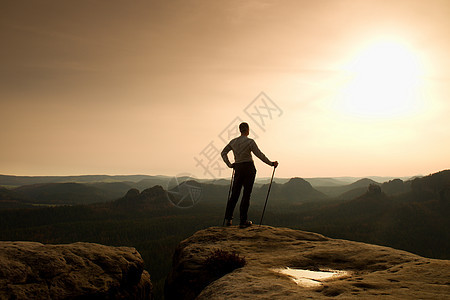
[0,0,450,177]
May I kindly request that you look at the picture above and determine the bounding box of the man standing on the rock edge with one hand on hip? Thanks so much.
[221,122,278,228]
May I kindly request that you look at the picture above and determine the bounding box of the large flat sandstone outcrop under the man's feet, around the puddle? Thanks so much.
[166,225,450,300]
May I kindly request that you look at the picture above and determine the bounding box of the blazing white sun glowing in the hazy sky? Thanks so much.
[337,40,421,118]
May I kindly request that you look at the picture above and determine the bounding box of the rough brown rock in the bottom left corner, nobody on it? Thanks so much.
[0,242,152,299]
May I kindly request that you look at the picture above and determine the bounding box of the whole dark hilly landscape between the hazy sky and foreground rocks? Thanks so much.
[0,170,450,298]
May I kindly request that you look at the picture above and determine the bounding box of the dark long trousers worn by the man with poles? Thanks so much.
[225,161,256,223]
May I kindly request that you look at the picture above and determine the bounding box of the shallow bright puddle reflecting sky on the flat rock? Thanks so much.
[272,268,349,287]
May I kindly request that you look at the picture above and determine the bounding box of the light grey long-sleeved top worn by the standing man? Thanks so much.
[221,135,273,168]
